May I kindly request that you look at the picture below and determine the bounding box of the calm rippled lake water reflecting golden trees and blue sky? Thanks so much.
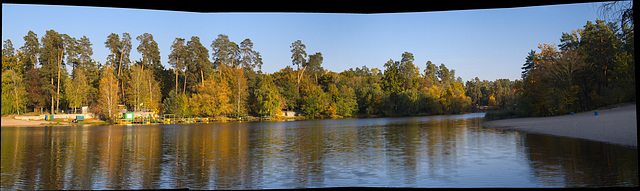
[1,114,638,189]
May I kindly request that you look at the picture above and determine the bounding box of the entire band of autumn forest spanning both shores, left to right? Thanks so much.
[2,20,635,120]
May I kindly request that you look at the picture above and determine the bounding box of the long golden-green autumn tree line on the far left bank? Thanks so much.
[2,30,470,119]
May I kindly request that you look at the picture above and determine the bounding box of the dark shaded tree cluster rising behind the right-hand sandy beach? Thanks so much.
[517,20,636,116]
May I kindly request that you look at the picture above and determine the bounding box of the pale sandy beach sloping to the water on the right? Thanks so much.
[482,104,638,148]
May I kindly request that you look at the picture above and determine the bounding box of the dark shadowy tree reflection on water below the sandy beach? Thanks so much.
[524,135,638,187]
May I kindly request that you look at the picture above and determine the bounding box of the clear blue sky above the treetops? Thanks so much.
[2,3,601,81]
